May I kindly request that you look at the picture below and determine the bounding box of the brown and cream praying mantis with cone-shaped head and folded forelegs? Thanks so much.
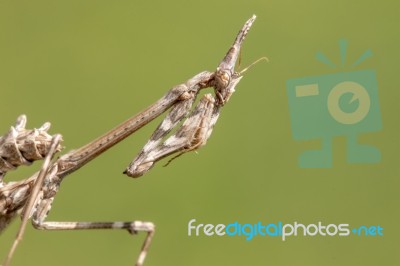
[0,15,265,266]
